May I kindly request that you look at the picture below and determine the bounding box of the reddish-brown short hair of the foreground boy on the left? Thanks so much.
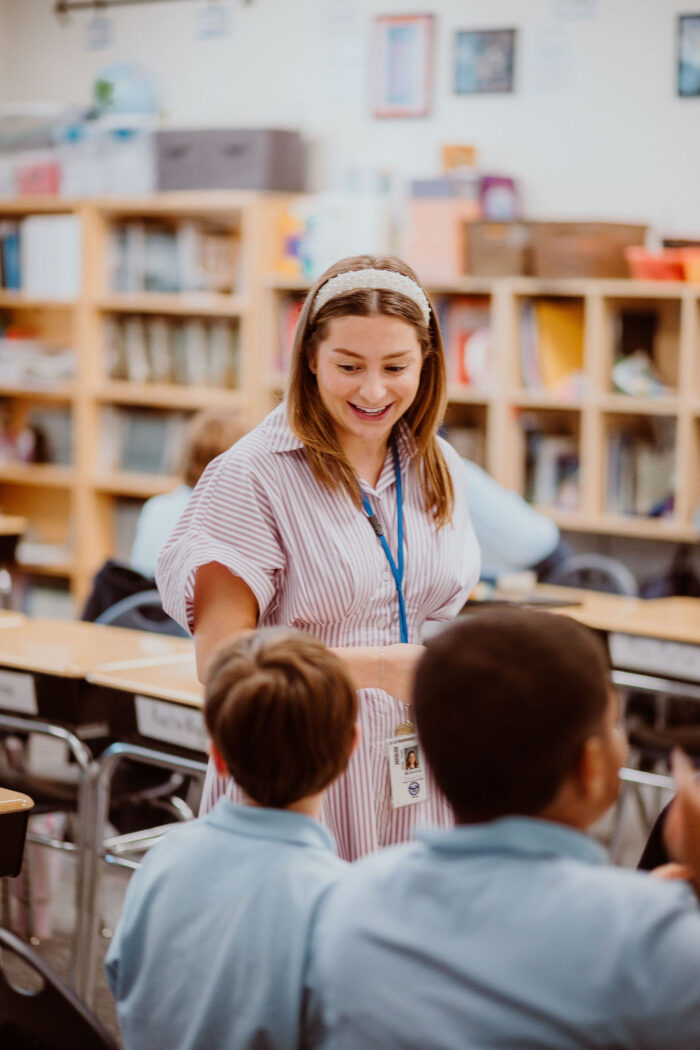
[205,628,357,809]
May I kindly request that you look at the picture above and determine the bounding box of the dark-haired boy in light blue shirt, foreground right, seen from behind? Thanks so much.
[310,610,700,1050]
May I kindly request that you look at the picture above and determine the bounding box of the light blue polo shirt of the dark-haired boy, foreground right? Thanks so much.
[310,818,700,1050]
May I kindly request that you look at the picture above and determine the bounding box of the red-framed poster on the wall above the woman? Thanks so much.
[372,15,434,117]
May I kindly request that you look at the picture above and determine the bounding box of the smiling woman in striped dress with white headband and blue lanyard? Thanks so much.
[157,256,479,860]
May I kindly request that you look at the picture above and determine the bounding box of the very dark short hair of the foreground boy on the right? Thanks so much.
[413,609,610,823]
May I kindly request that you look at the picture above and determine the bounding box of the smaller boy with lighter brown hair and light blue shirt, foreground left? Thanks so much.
[105,628,357,1050]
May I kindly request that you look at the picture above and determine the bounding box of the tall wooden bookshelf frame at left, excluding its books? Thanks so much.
[0,191,289,613]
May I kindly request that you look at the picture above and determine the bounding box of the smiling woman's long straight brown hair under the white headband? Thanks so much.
[287,255,454,528]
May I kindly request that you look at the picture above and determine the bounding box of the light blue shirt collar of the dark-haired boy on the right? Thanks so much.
[416,817,606,864]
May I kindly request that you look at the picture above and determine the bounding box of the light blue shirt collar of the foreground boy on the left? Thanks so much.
[201,798,336,854]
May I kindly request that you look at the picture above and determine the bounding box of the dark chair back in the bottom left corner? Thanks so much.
[0,927,119,1050]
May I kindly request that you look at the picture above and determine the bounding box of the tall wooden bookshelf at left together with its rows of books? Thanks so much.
[0,191,289,612]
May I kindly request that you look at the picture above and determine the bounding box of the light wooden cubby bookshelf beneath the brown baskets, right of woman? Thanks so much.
[266,276,700,542]
